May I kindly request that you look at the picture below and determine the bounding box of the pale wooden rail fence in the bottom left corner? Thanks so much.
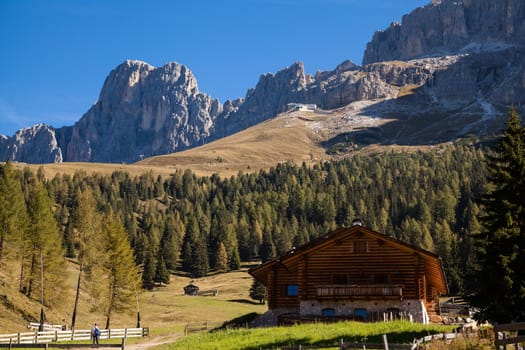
[0,327,149,344]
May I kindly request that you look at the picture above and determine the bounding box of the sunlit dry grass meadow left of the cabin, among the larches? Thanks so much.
[0,261,266,335]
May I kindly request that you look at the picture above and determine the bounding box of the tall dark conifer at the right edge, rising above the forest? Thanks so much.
[471,109,525,323]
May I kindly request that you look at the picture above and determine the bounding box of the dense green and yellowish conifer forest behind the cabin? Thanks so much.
[0,146,487,307]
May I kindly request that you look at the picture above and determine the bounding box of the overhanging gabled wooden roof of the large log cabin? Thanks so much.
[248,225,448,294]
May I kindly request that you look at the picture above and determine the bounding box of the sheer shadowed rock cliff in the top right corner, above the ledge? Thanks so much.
[363,0,525,65]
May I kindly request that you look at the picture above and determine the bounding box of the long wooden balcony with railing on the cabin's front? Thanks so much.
[316,284,403,300]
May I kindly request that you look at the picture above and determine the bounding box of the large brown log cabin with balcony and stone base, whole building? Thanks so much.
[249,223,448,325]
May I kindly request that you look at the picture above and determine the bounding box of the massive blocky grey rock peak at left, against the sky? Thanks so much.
[59,61,222,162]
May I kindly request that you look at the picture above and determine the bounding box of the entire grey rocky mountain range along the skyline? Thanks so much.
[0,0,525,163]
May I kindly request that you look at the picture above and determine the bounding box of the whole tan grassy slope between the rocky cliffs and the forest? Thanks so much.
[10,101,438,178]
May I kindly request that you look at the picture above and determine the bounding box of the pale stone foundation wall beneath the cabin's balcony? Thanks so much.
[300,299,429,324]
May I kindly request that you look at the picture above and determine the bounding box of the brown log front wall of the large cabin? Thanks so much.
[269,236,427,309]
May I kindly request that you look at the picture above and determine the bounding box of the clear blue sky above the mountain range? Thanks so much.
[0,0,430,136]
